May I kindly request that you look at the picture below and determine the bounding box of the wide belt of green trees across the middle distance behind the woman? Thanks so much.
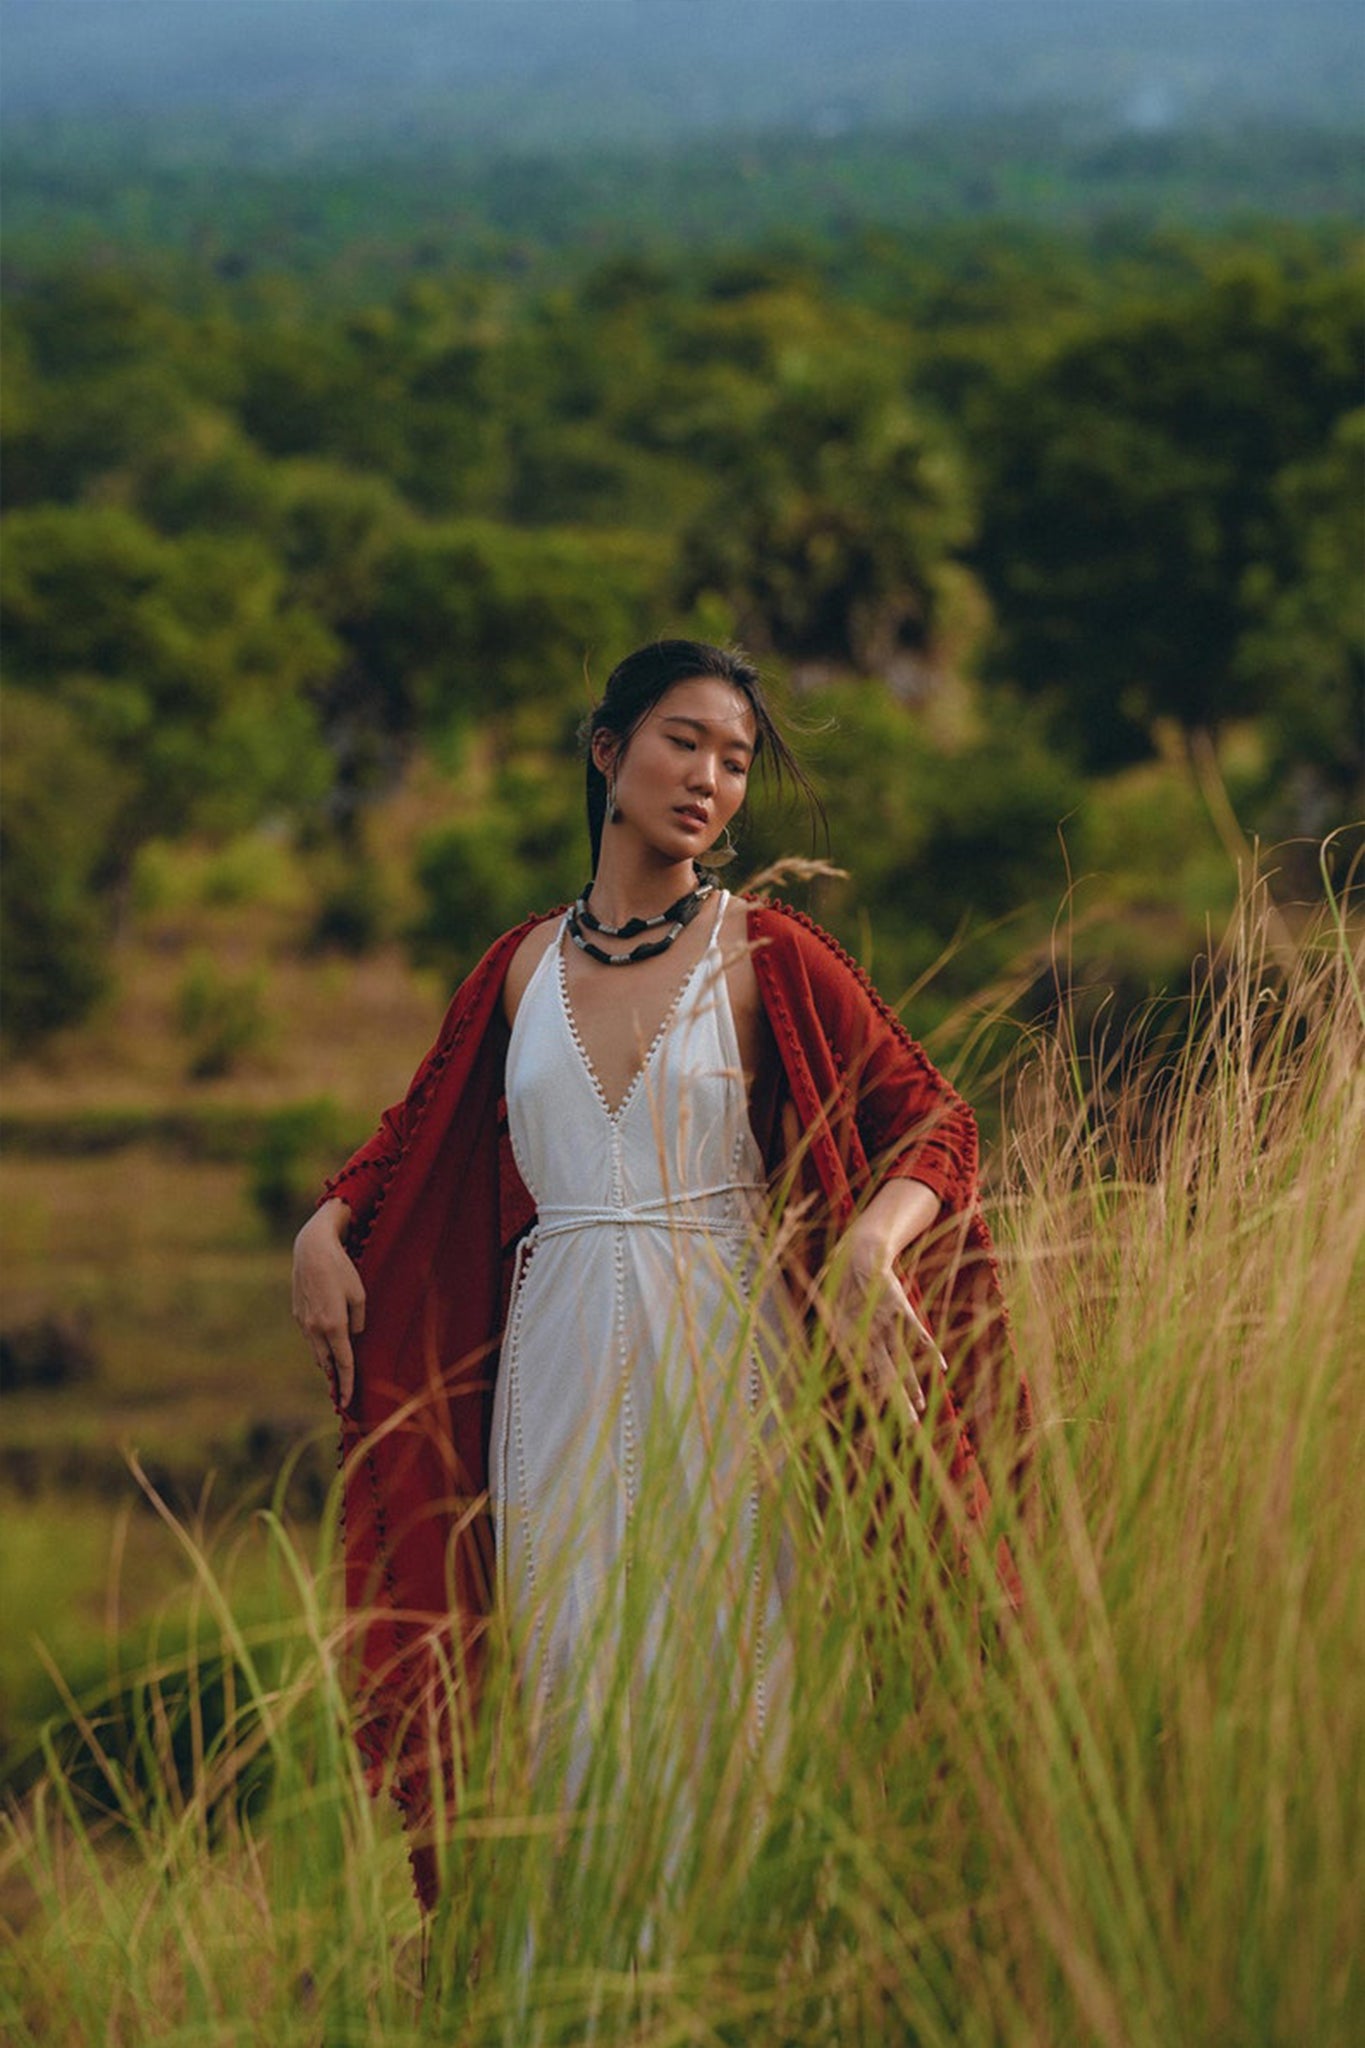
[2,232,1365,1042]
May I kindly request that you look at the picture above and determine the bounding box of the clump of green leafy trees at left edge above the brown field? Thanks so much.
[0,493,336,1038]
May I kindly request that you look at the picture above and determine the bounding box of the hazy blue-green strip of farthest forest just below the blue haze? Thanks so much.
[4,114,1359,288]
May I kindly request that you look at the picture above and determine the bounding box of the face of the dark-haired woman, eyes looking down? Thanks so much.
[593,676,757,860]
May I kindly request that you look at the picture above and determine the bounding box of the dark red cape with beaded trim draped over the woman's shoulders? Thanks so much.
[323,903,1029,1843]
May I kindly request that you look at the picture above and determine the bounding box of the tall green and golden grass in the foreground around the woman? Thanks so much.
[0,872,1365,2048]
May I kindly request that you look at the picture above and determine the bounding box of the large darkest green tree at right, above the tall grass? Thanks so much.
[978,264,1359,768]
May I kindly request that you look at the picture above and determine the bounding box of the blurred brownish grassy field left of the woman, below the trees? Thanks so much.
[0,774,458,1728]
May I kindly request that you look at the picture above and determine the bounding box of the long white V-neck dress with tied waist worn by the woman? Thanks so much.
[489,895,778,1786]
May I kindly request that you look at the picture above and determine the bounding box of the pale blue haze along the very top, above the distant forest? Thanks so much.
[0,0,1365,164]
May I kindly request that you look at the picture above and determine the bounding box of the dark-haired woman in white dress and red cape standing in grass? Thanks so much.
[295,641,1027,1898]
